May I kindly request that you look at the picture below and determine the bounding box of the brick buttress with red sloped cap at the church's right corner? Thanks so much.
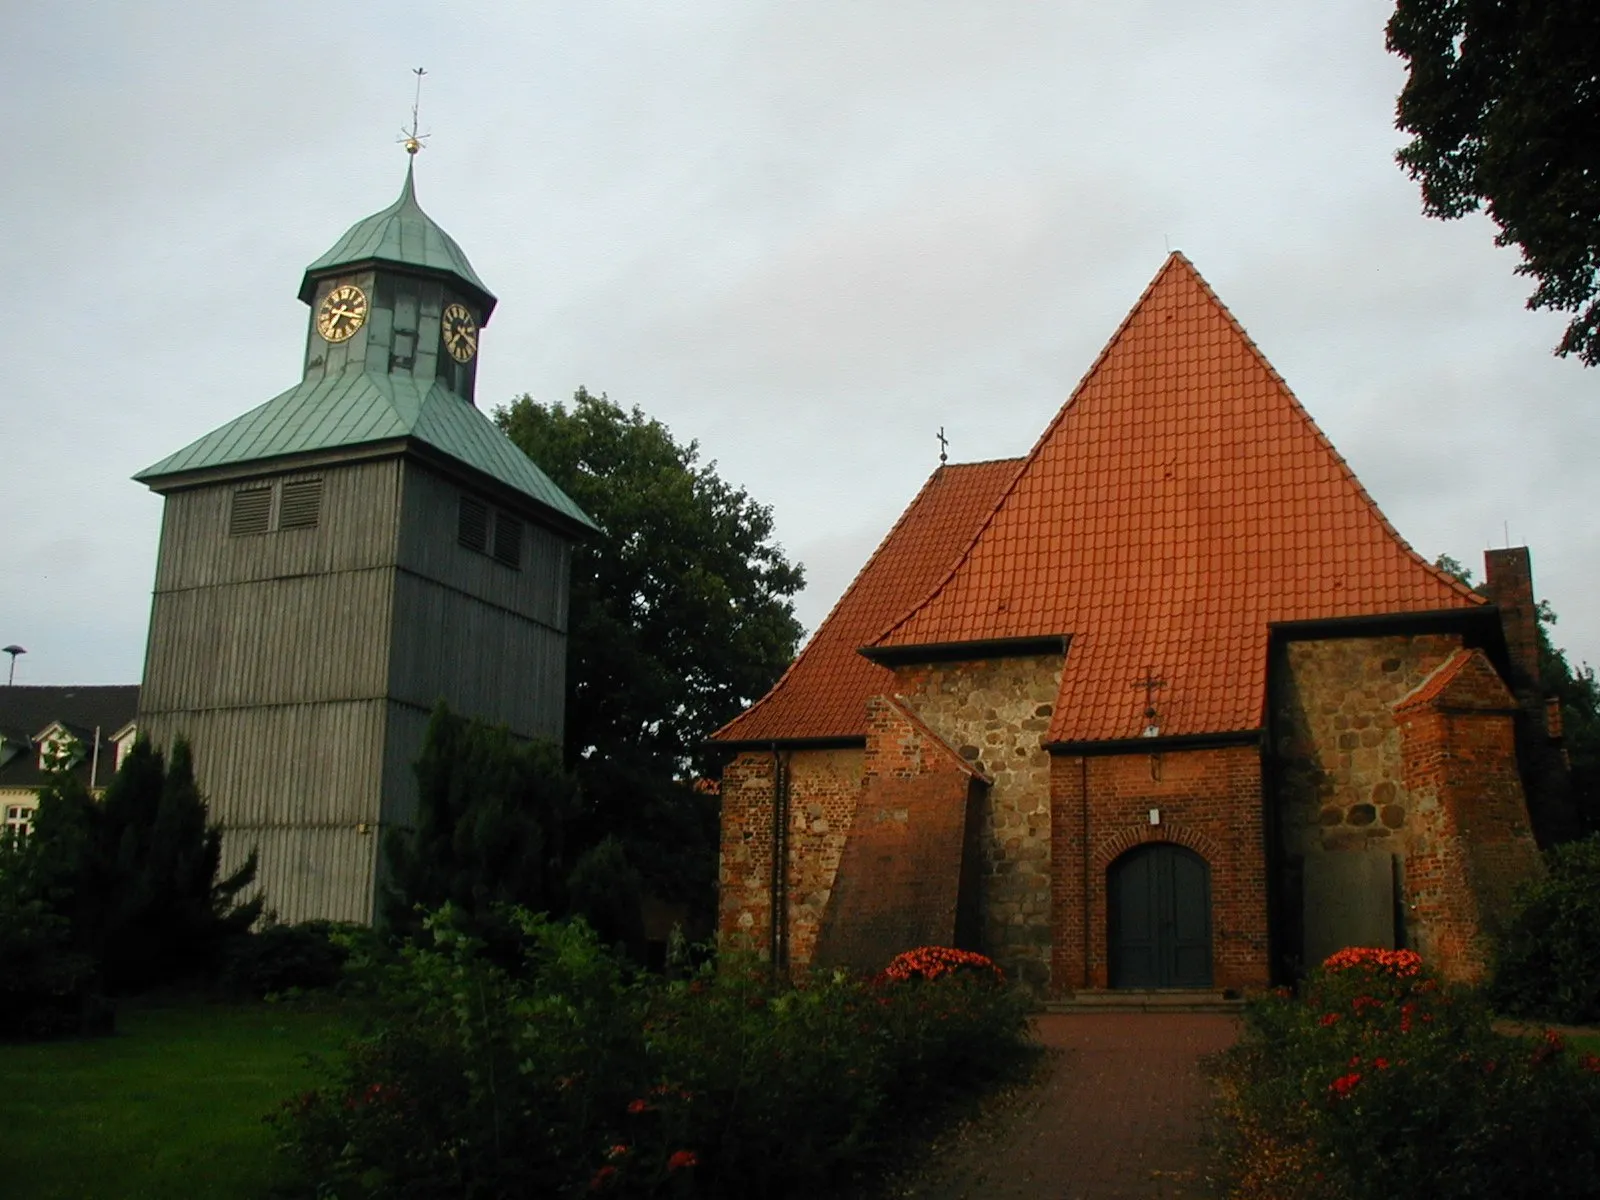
[1395,651,1542,982]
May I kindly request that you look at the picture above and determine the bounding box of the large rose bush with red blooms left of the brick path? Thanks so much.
[268,910,1027,1197]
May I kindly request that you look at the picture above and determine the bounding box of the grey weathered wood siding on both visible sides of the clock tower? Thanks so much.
[139,458,571,920]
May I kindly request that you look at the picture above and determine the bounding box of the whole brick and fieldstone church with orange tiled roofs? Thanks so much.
[715,254,1571,995]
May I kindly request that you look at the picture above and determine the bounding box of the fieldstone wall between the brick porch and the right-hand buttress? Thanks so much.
[1270,634,1461,965]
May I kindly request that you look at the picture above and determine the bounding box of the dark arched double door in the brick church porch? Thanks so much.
[1106,842,1211,987]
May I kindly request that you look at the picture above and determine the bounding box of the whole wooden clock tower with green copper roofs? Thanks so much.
[136,160,594,922]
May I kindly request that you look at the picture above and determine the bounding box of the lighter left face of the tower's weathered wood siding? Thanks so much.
[139,459,400,920]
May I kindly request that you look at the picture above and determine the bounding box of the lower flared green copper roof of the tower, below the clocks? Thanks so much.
[134,370,594,528]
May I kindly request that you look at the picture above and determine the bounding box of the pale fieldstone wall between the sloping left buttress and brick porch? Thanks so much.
[894,654,1064,992]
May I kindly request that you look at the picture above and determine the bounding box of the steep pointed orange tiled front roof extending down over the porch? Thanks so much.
[872,253,1485,741]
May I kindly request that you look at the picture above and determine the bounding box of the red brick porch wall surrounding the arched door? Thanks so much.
[1051,746,1269,994]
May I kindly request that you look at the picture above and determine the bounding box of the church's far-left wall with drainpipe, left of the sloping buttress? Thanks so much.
[717,747,862,971]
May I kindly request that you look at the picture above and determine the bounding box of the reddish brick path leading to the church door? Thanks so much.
[898,1013,1237,1200]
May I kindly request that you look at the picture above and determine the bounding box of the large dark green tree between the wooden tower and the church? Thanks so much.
[496,389,803,910]
